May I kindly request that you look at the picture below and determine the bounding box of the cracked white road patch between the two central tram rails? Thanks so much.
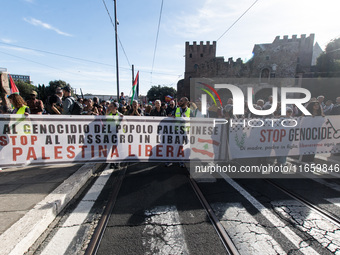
[143,206,189,254]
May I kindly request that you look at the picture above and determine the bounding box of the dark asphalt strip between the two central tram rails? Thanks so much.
[98,163,226,255]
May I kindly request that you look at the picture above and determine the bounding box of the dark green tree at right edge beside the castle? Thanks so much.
[316,38,340,77]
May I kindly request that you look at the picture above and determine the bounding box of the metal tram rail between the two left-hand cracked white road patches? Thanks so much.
[188,173,240,255]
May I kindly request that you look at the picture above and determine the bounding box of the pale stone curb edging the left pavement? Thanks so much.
[0,163,102,255]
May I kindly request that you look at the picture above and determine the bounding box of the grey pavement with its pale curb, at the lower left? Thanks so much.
[0,163,102,254]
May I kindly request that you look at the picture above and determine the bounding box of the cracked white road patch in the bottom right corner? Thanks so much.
[272,200,340,254]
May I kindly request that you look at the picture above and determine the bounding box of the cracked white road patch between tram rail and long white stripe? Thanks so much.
[212,203,286,255]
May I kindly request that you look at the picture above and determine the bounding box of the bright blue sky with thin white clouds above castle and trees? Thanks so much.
[0,0,340,95]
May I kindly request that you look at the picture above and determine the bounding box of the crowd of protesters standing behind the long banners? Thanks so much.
[0,86,340,119]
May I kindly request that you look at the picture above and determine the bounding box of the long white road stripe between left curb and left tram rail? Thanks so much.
[41,166,113,255]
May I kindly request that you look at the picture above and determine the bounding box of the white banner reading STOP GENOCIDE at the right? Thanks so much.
[229,116,340,158]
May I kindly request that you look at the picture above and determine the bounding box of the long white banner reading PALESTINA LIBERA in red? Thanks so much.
[0,114,227,167]
